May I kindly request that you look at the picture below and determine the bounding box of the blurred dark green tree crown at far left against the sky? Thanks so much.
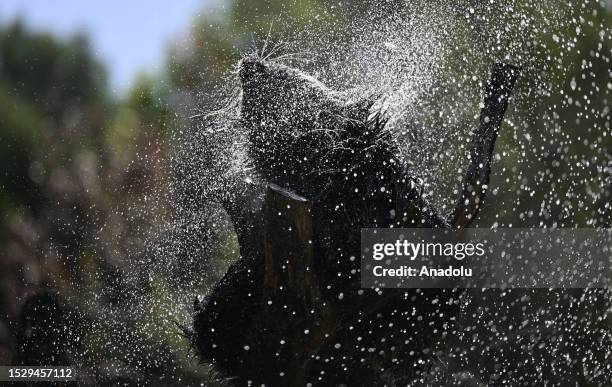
[0,21,109,208]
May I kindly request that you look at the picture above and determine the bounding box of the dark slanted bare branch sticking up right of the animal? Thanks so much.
[448,63,519,228]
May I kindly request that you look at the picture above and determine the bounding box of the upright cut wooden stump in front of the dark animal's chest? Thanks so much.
[251,185,337,385]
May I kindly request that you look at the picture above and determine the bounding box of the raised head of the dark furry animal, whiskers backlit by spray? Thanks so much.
[239,56,384,195]
